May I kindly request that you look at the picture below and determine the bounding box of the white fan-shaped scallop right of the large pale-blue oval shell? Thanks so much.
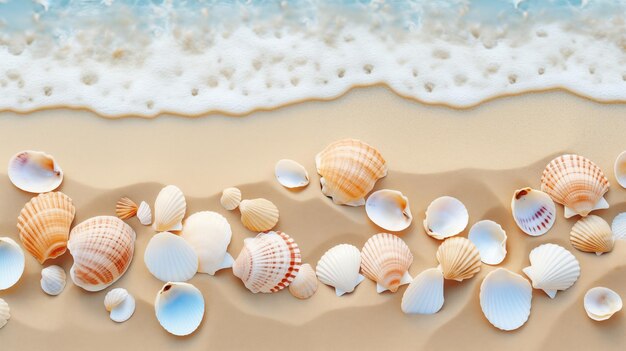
[522,244,580,299]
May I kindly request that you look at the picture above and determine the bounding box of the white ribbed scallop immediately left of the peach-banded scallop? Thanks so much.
[315,244,365,296]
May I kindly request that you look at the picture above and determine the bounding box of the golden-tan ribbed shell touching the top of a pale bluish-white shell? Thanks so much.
[437,237,481,282]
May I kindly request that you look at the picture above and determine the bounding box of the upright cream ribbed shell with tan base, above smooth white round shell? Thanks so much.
[154,185,187,232]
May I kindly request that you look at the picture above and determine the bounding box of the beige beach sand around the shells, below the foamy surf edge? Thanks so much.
[0,88,626,351]
